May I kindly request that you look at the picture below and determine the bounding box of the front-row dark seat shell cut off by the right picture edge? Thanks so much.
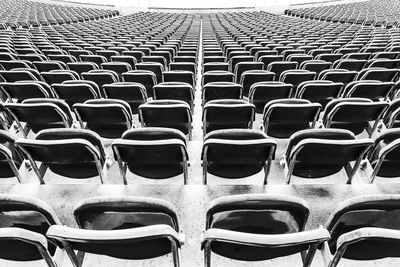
[327,194,400,260]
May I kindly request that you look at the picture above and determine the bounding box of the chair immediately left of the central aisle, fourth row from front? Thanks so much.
[153,82,194,112]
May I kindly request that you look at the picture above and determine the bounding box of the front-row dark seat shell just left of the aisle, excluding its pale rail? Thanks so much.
[50,197,180,259]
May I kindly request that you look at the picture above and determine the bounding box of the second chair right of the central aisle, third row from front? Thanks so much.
[262,99,322,138]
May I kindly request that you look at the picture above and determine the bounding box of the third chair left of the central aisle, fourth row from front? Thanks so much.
[51,80,101,107]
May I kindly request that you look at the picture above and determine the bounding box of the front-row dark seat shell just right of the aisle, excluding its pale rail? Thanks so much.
[206,194,309,261]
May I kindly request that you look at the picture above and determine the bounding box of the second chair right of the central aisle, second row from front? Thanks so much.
[282,129,374,184]
